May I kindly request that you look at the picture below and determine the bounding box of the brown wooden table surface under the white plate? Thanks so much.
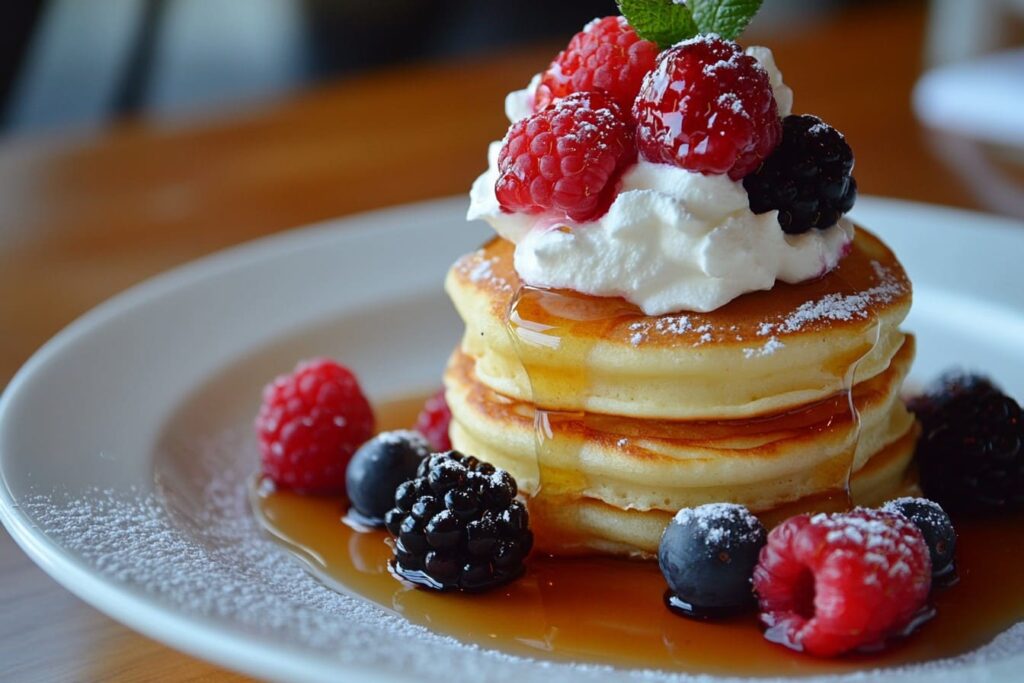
[0,3,987,681]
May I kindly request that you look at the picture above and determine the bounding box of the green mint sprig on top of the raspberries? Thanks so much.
[616,0,762,49]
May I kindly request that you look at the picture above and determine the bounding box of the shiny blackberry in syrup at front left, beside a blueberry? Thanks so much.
[384,451,534,592]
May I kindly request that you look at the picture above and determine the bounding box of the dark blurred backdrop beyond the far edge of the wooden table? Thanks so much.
[0,0,901,134]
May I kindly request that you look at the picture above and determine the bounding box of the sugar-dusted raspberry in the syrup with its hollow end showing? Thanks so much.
[754,508,932,656]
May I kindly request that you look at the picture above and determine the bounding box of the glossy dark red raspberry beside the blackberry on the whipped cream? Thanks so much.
[633,36,782,180]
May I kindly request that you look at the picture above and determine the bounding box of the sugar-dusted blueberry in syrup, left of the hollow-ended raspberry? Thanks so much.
[657,503,767,618]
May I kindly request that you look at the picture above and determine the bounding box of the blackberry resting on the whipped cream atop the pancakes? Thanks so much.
[743,115,857,234]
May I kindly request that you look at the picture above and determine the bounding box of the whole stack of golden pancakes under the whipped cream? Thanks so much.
[444,228,918,555]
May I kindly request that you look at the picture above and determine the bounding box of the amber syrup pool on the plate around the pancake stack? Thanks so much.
[252,397,1024,676]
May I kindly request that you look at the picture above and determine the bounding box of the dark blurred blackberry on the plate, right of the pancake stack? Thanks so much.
[910,375,1024,513]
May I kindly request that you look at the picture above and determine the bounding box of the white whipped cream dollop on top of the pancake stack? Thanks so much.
[467,47,854,315]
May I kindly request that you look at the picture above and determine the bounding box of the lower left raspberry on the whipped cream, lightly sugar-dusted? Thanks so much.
[495,92,636,222]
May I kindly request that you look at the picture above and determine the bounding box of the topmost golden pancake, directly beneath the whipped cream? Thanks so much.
[445,228,911,419]
